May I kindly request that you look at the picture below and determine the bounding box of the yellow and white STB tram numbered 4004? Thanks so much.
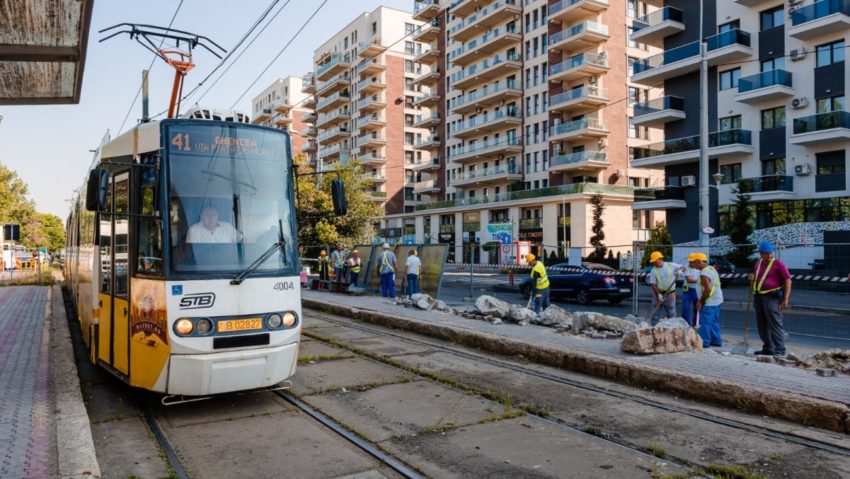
[66,118,301,396]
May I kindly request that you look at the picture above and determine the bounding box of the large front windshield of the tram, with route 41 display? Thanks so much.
[167,123,295,273]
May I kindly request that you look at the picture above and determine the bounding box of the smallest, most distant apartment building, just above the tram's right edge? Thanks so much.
[251,76,315,155]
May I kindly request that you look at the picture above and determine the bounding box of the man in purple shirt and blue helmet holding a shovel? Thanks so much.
[747,241,791,358]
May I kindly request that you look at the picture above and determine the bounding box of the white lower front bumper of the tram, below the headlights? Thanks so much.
[167,343,298,396]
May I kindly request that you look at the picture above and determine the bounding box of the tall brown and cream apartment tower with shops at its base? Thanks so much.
[384,0,663,263]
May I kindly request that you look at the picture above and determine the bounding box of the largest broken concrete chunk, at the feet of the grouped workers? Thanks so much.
[620,318,702,354]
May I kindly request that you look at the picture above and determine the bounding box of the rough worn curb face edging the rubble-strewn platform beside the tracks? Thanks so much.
[301,297,850,433]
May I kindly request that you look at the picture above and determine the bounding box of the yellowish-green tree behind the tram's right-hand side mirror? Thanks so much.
[294,155,382,251]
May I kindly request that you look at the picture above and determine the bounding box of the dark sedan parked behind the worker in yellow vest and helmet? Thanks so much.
[519,266,633,306]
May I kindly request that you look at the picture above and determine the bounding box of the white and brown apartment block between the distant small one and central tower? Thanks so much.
[303,6,430,219]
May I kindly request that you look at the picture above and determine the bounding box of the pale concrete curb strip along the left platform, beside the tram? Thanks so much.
[48,285,101,479]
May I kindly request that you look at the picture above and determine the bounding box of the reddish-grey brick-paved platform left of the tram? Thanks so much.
[0,286,99,478]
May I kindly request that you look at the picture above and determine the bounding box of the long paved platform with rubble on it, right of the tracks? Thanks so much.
[303,291,850,431]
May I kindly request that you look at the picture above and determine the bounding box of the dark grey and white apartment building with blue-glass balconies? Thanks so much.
[631,0,850,243]
